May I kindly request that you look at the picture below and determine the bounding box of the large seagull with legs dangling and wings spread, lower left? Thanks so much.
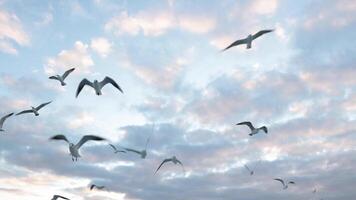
[50,135,105,161]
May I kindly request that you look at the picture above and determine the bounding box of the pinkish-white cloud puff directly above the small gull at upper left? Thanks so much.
[44,41,94,74]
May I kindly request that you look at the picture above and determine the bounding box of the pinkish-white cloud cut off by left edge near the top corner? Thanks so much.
[0,10,30,54]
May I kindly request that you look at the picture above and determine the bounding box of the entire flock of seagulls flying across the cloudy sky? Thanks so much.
[0,29,322,200]
